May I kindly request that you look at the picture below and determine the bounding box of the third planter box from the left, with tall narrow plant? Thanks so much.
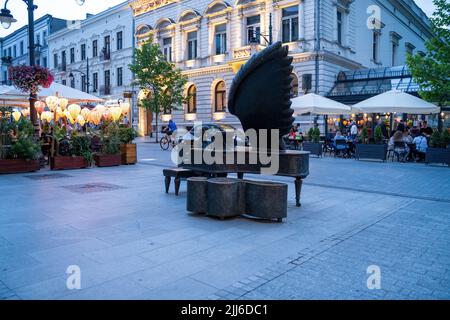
[94,122,122,167]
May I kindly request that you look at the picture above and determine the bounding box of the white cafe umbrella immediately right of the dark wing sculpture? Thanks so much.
[291,93,352,115]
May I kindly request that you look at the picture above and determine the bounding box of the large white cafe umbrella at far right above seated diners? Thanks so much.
[353,90,440,114]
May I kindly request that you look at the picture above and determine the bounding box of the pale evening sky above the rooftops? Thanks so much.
[0,0,434,37]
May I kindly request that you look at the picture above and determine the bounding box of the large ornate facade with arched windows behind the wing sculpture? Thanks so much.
[129,0,431,133]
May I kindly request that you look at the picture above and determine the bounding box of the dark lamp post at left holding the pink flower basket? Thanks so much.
[0,0,85,137]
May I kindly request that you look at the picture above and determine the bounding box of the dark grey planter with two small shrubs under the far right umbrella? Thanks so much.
[355,126,387,162]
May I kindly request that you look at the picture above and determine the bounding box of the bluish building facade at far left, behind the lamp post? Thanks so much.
[0,15,67,84]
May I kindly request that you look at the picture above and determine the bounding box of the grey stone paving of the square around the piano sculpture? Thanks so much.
[0,143,450,299]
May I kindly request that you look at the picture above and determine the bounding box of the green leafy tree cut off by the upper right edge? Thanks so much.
[407,0,450,106]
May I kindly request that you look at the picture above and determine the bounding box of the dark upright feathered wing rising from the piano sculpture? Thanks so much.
[228,42,295,149]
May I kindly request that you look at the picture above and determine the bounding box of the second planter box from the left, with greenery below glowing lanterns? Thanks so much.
[50,127,92,170]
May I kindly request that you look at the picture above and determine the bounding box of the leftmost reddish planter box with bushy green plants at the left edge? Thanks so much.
[0,118,40,173]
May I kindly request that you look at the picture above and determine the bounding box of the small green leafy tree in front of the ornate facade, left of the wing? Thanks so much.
[128,39,187,142]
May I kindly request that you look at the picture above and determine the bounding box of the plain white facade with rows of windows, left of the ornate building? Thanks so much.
[48,2,134,105]
